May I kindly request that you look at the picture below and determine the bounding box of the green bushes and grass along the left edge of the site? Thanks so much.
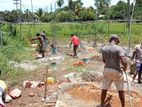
[0,24,32,81]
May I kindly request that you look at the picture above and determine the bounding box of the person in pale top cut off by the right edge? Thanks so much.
[132,43,142,84]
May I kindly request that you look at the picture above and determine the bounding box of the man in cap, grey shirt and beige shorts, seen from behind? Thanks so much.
[101,35,127,107]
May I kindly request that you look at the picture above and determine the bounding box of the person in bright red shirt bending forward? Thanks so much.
[70,34,79,58]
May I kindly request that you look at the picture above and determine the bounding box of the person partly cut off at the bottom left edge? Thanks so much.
[0,80,7,107]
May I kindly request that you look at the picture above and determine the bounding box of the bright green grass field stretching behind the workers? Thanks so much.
[17,22,142,44]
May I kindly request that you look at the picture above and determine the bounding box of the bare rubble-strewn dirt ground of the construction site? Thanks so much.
[6,42,142,107]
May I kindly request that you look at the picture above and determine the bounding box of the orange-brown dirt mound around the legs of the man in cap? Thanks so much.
[66,84,140,107]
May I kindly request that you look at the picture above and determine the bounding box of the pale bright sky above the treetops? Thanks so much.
[0,0,131,11]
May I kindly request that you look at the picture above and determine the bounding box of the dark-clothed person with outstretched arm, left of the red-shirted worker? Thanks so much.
[31,33,46,58]
